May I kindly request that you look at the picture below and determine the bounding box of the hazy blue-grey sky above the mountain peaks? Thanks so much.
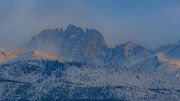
[0,0,180,49]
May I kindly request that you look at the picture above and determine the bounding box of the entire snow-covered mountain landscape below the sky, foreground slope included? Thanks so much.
[0,25,180,101]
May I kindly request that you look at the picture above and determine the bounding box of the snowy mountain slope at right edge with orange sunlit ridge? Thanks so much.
[130,43,180,77]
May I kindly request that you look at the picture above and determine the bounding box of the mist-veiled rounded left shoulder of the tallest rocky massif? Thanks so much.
[26,29,62,54]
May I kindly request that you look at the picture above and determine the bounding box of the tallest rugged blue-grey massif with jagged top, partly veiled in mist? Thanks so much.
[27,25,106,61]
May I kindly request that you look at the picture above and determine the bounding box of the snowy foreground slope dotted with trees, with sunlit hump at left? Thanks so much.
[0,48,180,101]
